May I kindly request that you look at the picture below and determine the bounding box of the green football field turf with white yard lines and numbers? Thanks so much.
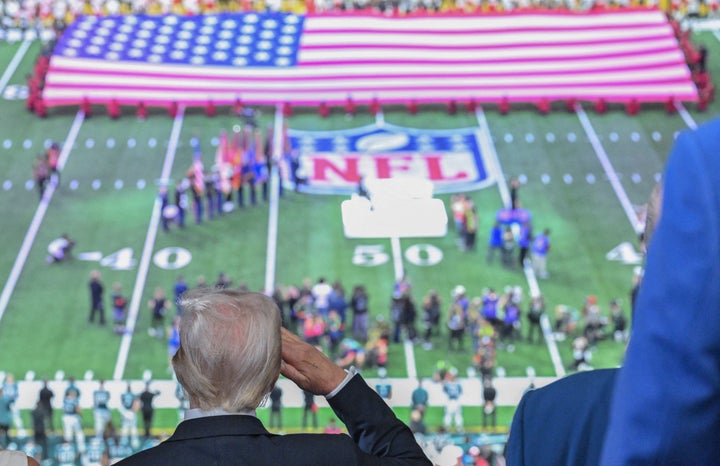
[0,33,720,432]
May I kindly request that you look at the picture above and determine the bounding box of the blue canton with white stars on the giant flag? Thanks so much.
[55,13,304,67]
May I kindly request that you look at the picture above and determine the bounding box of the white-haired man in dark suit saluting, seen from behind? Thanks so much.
[119,289,430,466]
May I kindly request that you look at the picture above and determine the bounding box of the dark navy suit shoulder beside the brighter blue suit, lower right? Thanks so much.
[507,369,618,466]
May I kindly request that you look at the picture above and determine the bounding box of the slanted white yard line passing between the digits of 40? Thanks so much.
[113,105,185,380]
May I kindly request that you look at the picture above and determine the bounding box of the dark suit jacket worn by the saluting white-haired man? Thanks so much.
[113,375,430,466]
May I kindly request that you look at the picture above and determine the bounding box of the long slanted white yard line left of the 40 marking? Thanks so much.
[0,112,85,319]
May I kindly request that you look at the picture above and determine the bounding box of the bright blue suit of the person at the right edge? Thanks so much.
[602,119,720,465]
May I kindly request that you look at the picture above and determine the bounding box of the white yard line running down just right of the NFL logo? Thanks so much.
[475,108,565,377]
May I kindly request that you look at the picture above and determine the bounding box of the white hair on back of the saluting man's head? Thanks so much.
[172,288,281,412]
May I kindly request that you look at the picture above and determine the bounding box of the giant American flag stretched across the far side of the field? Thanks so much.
[43,9,697,106]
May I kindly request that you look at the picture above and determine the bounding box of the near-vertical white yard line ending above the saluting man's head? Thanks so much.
[265,105,283,294]
